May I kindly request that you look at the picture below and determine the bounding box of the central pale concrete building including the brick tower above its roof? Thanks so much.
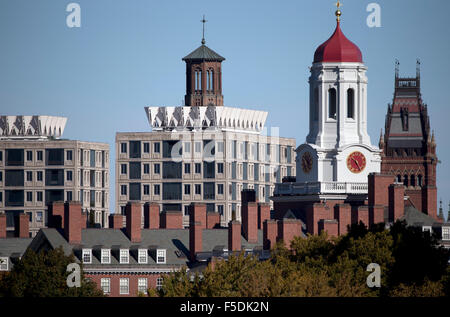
[115,32,295,226]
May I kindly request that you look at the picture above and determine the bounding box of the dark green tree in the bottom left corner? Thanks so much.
[0,248,103,297]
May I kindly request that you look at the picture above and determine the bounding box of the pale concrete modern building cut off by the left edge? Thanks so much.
[0,116,109,236]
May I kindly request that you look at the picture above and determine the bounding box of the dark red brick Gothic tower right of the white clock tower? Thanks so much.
[379,61,438,219]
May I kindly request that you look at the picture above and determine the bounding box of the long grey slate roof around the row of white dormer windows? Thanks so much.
[30,228,263,269]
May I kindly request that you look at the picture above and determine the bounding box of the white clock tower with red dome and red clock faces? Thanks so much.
[296,8,381,185]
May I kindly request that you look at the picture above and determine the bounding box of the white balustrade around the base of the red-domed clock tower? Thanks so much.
[274,182,368,196]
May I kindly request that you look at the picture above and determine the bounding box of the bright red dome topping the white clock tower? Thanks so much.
[314,22,362,63]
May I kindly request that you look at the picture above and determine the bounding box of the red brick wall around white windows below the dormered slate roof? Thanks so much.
[85,274,161,297]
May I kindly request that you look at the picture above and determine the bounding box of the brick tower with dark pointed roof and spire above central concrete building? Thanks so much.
[183,17,225,106]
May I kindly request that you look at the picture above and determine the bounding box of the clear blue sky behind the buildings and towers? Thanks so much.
[0,0,450,218]
